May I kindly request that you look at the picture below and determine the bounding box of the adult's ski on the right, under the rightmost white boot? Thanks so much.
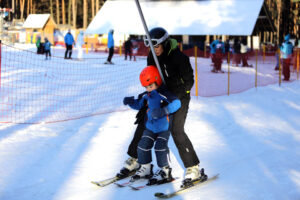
[154,174,219,199]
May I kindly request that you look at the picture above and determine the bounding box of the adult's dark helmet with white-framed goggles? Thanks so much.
[144,27,169,47]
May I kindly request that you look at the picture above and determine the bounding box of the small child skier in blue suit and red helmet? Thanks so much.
[123,66,181,185]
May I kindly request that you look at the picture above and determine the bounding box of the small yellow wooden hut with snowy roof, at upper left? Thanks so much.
[23,14,57,44]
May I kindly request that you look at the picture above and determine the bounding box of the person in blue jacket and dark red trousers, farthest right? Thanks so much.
[280,34,293,81]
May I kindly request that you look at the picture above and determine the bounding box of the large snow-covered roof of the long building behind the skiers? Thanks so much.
[86,0,264,35]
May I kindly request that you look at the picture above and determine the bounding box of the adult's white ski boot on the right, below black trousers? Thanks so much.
[181,165,207,187]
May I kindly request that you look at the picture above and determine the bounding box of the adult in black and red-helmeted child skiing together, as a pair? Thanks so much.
[117,27,201,185]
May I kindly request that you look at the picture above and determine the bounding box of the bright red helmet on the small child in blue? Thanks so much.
[140,65,162,87]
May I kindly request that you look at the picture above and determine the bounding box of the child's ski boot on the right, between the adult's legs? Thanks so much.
[147,166,174,185]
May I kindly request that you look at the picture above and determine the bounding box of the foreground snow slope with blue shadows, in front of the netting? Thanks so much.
[0,45,300,200]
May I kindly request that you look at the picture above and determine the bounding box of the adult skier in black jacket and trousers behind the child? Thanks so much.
[117,27,201,185]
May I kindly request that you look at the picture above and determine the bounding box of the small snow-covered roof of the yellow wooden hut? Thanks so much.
[23,14,50,28]
